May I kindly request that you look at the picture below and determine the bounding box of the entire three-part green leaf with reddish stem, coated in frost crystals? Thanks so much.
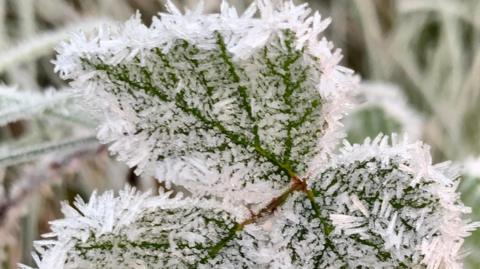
[26,0,477,269]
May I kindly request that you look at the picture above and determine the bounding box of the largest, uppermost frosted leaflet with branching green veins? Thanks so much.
[56,1,354,203]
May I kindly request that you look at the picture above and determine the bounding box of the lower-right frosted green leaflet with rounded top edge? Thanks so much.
[272,137,478,268]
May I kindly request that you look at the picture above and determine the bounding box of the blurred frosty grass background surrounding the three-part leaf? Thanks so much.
[0,0,480,268]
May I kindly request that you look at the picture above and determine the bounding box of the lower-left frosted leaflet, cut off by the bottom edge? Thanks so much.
[22,188,270,269]
